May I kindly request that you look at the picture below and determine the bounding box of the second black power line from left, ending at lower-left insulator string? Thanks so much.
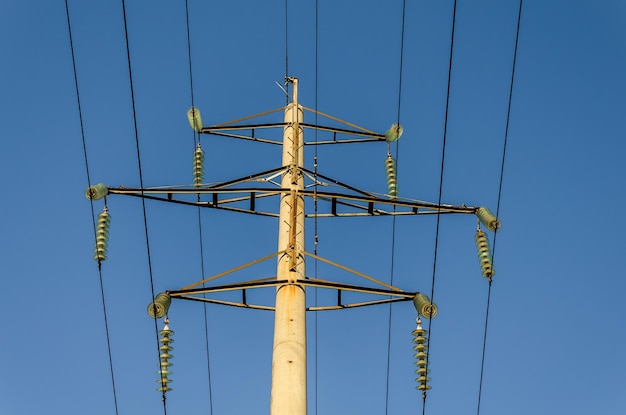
[122,0,167,414]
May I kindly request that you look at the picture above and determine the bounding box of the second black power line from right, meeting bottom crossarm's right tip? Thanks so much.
[422,0,456,414]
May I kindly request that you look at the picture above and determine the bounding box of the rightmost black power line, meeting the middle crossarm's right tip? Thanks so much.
[476,0,523,414]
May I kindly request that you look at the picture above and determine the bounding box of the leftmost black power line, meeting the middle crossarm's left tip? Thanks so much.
[65,0,119,414]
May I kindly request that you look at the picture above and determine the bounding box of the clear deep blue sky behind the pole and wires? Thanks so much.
[0,0,626,415]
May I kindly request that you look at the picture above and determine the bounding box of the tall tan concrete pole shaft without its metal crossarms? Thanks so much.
[270,78,307,415]
